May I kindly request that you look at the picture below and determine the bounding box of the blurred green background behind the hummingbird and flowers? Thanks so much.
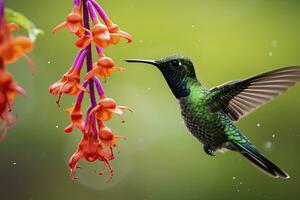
[0,0,300,200]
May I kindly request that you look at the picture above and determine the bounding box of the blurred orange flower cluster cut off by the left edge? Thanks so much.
[0,0,37,140]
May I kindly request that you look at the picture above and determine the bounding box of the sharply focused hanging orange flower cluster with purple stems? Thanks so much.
[49,0,132,180]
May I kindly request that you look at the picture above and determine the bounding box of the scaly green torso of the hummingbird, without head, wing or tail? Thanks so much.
[178,82,240,152]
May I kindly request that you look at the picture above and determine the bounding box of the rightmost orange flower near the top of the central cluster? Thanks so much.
[105,18,132,44]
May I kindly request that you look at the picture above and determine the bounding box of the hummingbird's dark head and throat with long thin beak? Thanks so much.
[126,55,197,98]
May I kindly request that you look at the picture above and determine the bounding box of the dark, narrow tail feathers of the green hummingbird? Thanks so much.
[234,142,289,179]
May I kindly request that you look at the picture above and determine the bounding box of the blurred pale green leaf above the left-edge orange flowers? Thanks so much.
[5,8,44,42]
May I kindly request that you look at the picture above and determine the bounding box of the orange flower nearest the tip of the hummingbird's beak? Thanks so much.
[85,57,125,80]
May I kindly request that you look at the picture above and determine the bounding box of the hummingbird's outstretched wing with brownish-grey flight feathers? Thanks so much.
[208,66,300,121]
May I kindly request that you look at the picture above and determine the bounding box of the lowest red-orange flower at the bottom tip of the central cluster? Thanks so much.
[69,132,114,181]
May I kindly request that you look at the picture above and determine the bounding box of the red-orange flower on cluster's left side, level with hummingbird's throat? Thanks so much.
[49,67,85,104]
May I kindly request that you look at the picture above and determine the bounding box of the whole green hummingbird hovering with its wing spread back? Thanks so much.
[126,55,300,179]
